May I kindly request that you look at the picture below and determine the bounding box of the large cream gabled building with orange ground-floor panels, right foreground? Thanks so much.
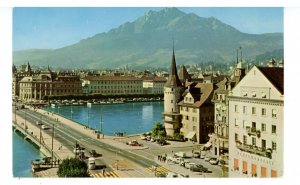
[228,65,284,177]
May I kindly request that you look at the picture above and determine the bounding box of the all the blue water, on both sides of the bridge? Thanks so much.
[13,102,163,177]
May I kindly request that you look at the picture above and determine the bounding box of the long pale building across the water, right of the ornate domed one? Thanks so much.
[82,76,143,95]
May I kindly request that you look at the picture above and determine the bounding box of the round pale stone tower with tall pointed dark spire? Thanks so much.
[163,44,183,136]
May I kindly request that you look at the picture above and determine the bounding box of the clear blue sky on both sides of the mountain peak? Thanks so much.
[13,7,283,51]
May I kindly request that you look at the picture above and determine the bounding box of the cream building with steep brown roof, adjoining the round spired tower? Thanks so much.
[178,83,214,143]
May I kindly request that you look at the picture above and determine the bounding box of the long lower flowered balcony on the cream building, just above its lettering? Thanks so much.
[236,141,272,159]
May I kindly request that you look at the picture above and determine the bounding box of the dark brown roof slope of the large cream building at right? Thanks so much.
[257,67,284,94]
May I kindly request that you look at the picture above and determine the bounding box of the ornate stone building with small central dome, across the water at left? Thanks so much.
[19,67,82,102]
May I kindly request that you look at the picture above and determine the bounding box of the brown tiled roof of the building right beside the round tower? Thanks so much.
[178,83,214,107]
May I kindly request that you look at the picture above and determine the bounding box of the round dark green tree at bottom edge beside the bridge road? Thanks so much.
[57,158,89,177]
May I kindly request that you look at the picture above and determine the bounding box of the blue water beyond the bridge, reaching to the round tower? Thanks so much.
[45,102,163,135]
